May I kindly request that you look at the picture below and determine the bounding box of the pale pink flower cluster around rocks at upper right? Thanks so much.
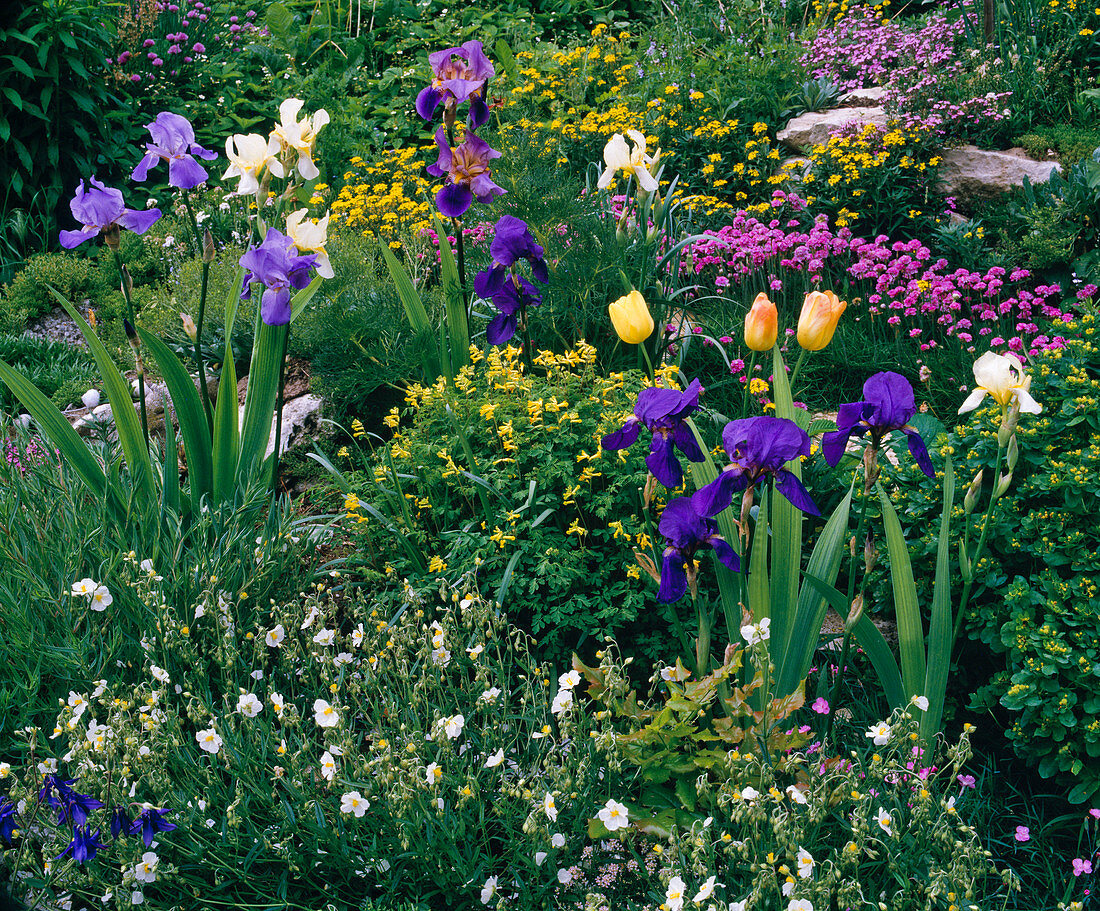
[802,7,1012,136]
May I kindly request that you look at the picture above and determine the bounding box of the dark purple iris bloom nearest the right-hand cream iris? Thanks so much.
[822,371,936,478]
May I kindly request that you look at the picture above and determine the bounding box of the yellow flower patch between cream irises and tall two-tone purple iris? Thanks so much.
[332,145,436,248]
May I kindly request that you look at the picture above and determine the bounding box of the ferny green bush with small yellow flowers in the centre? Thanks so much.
[334,345,653,656]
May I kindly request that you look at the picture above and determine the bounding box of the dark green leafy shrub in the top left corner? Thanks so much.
[0,0,140,254]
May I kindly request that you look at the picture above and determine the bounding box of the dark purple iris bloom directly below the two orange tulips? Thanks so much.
[692,415,821,516]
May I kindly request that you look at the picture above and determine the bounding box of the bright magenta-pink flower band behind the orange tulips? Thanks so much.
[682,190,1078,353]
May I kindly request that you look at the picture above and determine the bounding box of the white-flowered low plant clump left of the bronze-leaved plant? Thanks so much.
[0,585,616,911]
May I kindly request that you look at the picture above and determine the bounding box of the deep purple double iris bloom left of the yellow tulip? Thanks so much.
[474,216,550,344]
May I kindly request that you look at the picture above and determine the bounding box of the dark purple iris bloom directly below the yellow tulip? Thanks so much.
[601,380,704,490]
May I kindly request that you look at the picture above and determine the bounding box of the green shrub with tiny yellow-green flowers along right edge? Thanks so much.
[897,314,1100,802]
